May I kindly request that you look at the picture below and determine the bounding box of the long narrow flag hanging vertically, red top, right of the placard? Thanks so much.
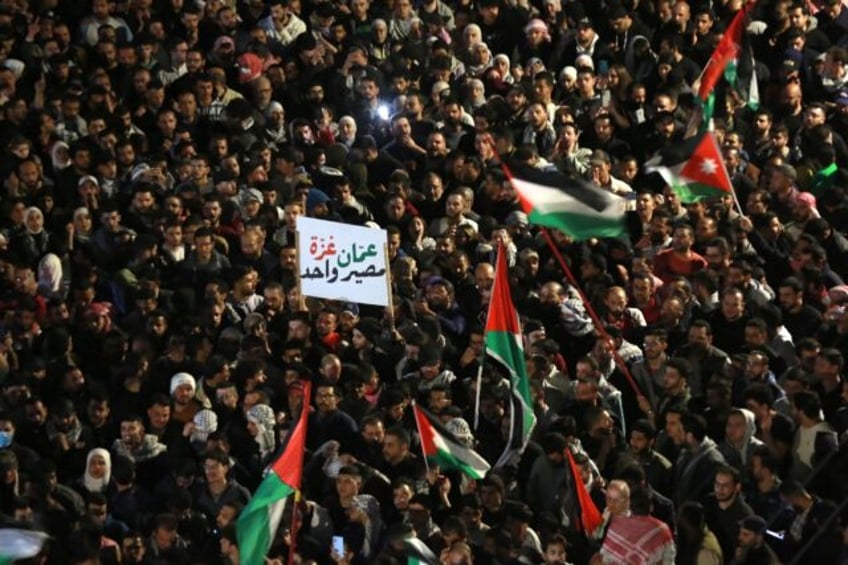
[485,243,536,467]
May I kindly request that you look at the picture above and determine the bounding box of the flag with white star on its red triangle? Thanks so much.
[645,131,733,204]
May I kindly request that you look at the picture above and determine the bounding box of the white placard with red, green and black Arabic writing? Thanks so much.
[297,217,390,306]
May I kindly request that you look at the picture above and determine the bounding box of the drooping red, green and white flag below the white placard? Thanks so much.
[236,381,311,564]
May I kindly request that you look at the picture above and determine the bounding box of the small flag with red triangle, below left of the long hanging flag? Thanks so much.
[412,404,489,479]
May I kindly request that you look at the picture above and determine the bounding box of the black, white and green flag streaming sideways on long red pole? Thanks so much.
[504,162,626,240]
